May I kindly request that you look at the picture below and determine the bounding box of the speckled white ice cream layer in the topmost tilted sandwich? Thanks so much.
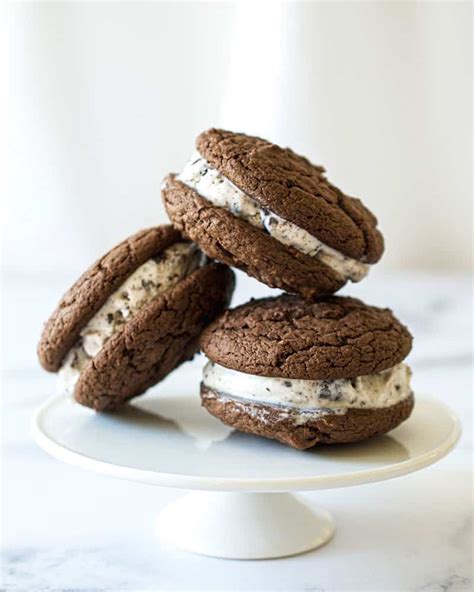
[177,152,369,282]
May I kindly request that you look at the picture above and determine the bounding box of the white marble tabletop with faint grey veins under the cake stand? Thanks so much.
[2,270,472,592]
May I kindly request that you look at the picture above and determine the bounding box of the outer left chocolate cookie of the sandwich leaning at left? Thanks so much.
[38,226,182,372]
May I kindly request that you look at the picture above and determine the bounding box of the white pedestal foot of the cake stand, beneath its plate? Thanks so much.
[156,491,334,559]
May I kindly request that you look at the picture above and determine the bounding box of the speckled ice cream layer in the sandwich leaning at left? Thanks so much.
[58,242,206,394]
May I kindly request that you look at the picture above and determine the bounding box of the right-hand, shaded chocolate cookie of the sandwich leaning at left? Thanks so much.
[74,263,234,411]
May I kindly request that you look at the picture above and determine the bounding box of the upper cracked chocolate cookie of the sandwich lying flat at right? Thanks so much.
[200,294,412,380]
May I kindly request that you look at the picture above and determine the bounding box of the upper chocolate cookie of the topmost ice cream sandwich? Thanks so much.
[196,129,384,263]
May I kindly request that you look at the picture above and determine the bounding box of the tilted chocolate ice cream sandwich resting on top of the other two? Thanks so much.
[163,129,383,298]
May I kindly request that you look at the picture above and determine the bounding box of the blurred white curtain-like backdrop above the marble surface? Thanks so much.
[4,2,472,278]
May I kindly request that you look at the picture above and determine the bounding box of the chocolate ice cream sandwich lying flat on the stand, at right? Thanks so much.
[200,295,414,449]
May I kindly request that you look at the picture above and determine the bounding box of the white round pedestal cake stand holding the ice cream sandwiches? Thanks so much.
[33,381,461,559]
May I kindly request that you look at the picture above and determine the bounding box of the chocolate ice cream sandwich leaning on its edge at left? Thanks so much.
[38,226,234,411]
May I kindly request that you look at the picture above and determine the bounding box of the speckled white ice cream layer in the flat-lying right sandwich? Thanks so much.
[203,362,412,415]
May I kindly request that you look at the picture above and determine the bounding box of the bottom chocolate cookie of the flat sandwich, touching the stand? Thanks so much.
[201,384,415,450]
